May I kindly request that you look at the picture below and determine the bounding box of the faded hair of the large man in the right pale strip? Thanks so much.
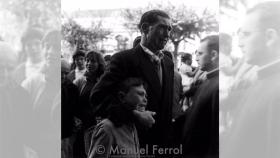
[247,1,280,31]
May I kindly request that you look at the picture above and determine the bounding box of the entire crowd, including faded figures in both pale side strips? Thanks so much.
[0,1,280,158]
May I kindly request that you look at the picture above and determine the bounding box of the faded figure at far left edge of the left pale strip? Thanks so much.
[0,42,34,158]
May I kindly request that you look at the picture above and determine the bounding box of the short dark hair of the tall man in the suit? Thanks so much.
[138,10,170,30]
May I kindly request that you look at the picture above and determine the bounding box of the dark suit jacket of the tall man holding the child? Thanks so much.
[90,45,174,145]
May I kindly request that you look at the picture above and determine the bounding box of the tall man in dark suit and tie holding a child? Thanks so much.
[90,10,174,154]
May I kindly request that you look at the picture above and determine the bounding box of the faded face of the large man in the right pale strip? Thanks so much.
[238,12,265,65]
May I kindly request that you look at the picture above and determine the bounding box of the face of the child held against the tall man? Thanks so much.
[123,85,147,111]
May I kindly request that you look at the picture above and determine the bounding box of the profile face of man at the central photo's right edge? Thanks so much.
[195,41,212,71]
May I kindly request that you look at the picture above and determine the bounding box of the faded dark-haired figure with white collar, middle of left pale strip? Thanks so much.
[14,28,44,84]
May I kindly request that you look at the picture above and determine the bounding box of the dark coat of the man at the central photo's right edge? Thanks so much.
[183,70,219,158]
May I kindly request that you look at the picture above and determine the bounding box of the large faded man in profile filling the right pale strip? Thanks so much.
[221,1,280,158]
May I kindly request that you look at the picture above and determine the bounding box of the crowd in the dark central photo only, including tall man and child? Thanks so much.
[61,10,219,158]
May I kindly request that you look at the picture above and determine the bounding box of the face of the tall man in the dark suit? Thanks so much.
[146,16,172,51]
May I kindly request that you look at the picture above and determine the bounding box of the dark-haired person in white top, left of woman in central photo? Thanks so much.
[67,50,86,82]
